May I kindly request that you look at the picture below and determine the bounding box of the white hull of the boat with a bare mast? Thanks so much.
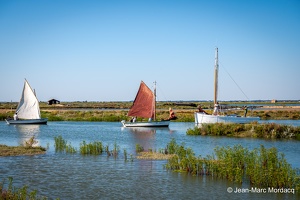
[195,112,260,124]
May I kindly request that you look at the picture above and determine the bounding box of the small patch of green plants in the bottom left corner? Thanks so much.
[0,177,47,200]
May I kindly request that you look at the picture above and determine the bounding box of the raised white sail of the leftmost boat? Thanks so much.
[16,79,41,119]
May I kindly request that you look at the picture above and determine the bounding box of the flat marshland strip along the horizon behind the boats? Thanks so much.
[0,101,300,122]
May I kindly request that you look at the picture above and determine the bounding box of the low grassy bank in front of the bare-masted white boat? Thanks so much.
[186,122,300,140]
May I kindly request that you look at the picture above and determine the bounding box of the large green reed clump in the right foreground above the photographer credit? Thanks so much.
[165,139,300,190]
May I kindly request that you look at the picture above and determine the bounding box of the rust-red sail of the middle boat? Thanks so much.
[128,81,155,119]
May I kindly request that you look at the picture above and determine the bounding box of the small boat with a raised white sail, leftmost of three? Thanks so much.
[5,79,48,124]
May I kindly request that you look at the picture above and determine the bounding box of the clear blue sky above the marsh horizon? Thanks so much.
[0,0,300,101]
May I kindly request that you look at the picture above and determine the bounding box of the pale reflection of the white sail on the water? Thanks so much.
[14,124,41,146]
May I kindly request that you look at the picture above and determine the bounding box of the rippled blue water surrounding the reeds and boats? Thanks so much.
[0,121,300,199]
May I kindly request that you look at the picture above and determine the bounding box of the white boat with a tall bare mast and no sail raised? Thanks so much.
[195,48,260,124]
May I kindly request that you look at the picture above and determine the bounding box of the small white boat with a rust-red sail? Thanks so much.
[121,81,170,127]
